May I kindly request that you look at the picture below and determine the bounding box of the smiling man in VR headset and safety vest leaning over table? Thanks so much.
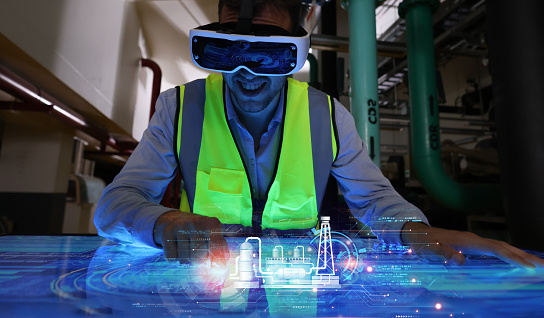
[95,0,544,269]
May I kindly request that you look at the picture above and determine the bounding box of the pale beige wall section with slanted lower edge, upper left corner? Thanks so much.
[0,0,150,137]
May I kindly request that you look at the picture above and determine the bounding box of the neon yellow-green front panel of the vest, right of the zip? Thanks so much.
[262,79,318,230]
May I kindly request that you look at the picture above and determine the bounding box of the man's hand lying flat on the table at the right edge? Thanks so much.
[401,222,544,269]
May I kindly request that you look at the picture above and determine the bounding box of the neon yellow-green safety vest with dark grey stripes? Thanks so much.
[174,74,338,230]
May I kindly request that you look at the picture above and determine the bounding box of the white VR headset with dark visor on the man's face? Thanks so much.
[189,0,310,76]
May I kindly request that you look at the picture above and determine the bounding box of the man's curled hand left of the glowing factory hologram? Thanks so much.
[153,211,229,264]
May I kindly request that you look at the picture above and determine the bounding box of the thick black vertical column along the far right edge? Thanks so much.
[487,0,544,250]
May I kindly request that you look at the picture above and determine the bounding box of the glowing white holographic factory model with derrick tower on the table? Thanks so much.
[230,216,340,289]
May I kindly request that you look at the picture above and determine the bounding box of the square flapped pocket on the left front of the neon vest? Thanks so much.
[193,167,246,224]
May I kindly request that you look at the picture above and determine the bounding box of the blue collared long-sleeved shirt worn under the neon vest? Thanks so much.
[95,80,428,246]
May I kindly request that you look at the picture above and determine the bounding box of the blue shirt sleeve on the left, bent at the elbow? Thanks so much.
[94,89,177,247]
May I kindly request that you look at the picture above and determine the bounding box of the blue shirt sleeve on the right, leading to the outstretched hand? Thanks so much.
[331,100,428,245]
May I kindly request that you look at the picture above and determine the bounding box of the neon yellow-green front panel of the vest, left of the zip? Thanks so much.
[193,76,253,226]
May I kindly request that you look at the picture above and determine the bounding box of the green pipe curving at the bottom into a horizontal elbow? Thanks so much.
[399,0,502,211]
